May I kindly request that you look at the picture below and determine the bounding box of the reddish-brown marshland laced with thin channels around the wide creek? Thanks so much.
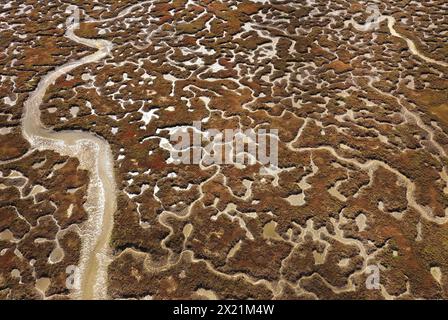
[0,0,448,299]
